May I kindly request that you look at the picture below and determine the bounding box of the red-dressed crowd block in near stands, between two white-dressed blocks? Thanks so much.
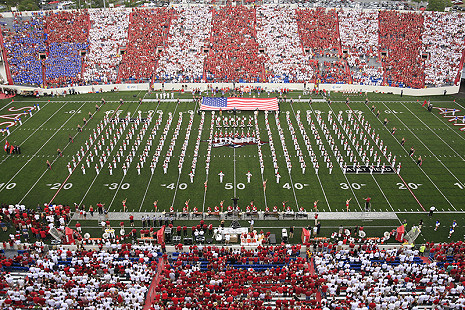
[151,246,319,310]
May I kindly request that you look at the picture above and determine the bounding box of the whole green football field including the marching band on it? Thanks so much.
[0,92,465,242]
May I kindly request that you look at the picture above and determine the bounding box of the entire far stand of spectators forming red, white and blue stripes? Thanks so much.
[2,5,465,88]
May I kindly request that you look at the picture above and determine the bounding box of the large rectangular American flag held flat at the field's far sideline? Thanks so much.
[200,97,279,111]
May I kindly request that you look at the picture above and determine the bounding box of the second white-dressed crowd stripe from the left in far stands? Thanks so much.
[156,6,212,83]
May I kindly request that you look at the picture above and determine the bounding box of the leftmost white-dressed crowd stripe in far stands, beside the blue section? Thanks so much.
[84,8,130,83]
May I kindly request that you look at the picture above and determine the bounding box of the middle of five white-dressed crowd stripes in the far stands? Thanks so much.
[257,6,314,83]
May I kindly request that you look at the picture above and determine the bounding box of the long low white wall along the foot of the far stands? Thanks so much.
[4,83,460,96]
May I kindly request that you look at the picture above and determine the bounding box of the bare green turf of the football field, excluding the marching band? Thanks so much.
[0,92,465,245]
